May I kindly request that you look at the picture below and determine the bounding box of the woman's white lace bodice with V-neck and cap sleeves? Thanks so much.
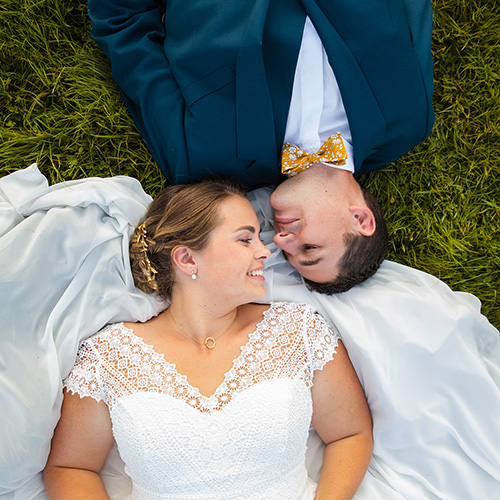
[65,303,338,500]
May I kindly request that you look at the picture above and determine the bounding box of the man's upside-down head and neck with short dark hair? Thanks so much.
[270,163,387,294]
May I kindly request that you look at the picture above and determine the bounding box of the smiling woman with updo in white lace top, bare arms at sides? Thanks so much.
[44,181,373,500]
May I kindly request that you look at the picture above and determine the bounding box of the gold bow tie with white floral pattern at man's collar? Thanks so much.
[281,132,348,176]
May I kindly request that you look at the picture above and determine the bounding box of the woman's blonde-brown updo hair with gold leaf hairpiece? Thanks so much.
[130,179,245,300]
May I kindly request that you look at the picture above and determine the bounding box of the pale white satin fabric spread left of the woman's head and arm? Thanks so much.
[0,166,164,500]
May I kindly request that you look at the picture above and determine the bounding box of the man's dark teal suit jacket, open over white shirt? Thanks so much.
[89,0,434,188]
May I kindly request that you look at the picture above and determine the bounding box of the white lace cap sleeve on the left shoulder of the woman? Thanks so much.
[63,339,106,402]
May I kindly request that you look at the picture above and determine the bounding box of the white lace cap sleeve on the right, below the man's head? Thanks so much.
[306,310,340,374]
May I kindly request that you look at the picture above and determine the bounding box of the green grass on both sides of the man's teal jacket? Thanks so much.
[0,0,500,328]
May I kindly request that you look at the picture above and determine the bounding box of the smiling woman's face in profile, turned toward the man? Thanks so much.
[196,196,270,305]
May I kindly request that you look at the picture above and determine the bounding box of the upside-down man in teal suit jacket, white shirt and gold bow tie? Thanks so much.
[89,0,434,293]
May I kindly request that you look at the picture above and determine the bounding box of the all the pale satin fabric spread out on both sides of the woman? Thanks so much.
[0,165,500,500]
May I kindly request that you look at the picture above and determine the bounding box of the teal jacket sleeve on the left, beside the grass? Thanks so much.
[88,0,186,180]
